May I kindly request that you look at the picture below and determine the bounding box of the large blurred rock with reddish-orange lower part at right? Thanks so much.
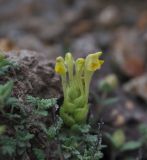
[112,28,147,77]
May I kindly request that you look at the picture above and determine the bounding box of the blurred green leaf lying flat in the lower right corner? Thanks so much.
[121,141,142,151]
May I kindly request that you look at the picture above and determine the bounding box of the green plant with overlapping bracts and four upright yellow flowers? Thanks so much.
[55,52,104,128]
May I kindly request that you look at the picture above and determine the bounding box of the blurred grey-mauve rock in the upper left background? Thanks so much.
[22,15,65,41]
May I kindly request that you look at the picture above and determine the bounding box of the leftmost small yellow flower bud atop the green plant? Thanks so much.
[55,57,66,75]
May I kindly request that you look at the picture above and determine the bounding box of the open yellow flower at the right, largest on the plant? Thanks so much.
[85,52,104,71]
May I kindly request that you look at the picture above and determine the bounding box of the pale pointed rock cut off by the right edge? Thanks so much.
[123,74,147,101]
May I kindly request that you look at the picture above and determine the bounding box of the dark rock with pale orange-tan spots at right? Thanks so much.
[100,91,147,127]
